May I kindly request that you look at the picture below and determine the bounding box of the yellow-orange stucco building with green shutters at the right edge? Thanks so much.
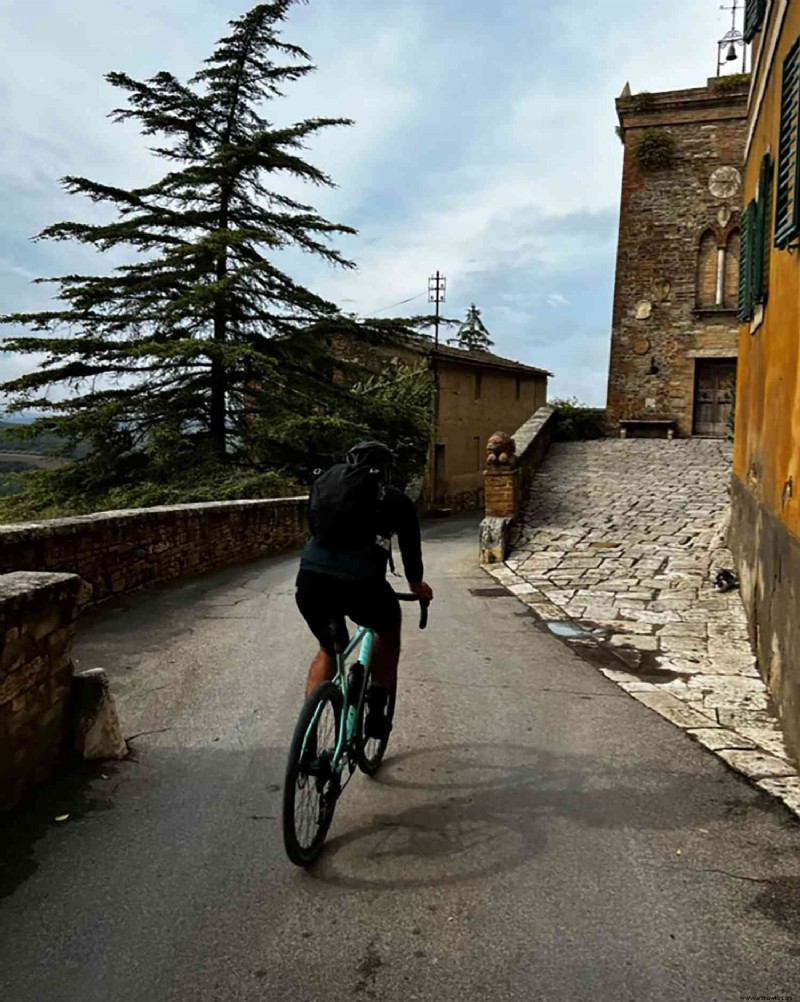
[731,0,800,757]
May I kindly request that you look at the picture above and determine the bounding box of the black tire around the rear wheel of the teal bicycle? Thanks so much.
[283,682,343,867]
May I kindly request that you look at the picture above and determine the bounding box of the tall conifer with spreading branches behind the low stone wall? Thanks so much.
[0,0,425,513]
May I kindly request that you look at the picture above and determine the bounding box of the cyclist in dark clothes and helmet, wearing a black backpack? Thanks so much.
[296,442,433,739]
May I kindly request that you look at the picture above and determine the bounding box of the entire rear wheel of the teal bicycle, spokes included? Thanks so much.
[283,682,342,867]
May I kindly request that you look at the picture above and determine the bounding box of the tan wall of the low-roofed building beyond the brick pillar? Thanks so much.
[431,360,547,510]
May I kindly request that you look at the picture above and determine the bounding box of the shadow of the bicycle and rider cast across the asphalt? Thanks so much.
[310,742,800,917]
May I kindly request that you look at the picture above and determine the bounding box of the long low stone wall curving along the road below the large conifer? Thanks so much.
[0,498,308,603]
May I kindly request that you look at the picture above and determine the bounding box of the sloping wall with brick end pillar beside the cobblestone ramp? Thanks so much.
[480,407,557,564]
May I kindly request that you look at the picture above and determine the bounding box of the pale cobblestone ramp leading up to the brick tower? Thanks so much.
[488,439,800,813]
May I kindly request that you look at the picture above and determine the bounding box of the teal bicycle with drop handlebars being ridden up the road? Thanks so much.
[283,593,429,867]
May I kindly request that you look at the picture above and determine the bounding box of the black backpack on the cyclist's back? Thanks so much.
[309,463,385,550]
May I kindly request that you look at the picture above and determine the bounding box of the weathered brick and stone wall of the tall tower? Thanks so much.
[609,80,748,435]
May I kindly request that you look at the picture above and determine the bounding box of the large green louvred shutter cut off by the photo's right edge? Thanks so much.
[775,38,800,251]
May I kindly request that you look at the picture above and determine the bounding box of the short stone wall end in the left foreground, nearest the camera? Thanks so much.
[0,572,88,810]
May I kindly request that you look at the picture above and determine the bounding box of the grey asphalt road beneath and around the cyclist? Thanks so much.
[0,520,800,1002]
